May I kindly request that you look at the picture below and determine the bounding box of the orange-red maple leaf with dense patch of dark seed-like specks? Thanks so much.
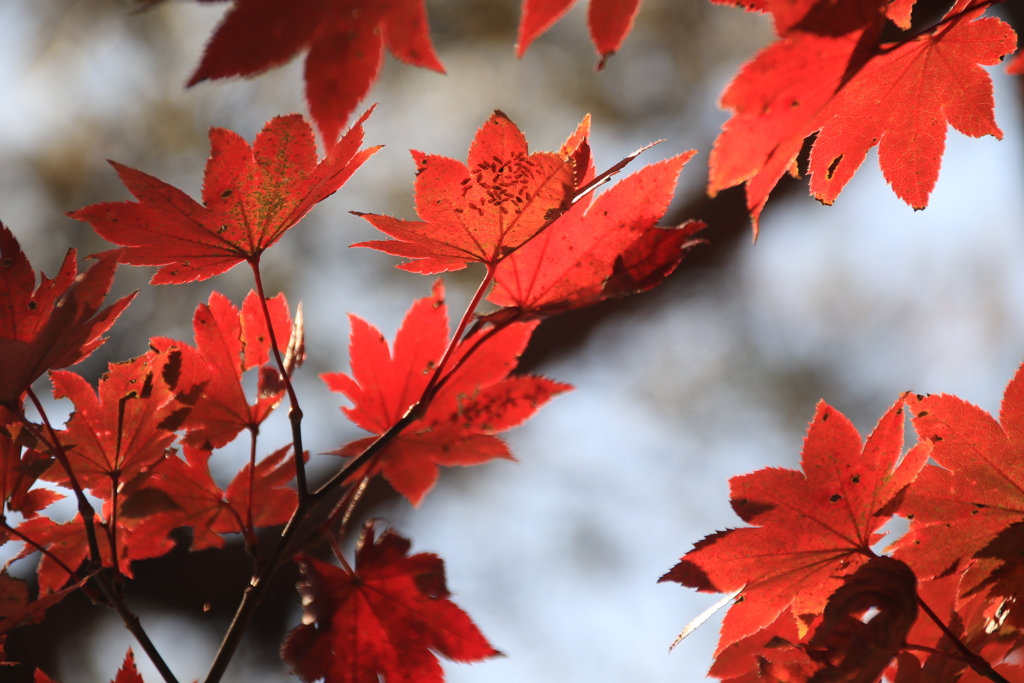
[352,112,575,273]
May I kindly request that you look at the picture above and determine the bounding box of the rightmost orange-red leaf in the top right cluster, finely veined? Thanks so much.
[810,8,1017,209]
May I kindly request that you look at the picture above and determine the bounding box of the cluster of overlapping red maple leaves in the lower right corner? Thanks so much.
[662,366,1024,683]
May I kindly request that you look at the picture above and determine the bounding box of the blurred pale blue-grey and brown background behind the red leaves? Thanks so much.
[0,0,1024,683]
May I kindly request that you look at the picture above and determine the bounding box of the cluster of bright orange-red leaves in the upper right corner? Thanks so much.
[708,0,1017,234]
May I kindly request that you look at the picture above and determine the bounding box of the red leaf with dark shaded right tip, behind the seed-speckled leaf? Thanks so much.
[487,152,705,317]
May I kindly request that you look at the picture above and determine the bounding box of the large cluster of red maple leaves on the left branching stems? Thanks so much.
[0,104,703,683]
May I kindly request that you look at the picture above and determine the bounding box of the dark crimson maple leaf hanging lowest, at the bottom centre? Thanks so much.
[281,523,500,683]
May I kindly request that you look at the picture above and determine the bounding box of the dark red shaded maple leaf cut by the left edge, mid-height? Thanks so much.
[0,223,135,405]
